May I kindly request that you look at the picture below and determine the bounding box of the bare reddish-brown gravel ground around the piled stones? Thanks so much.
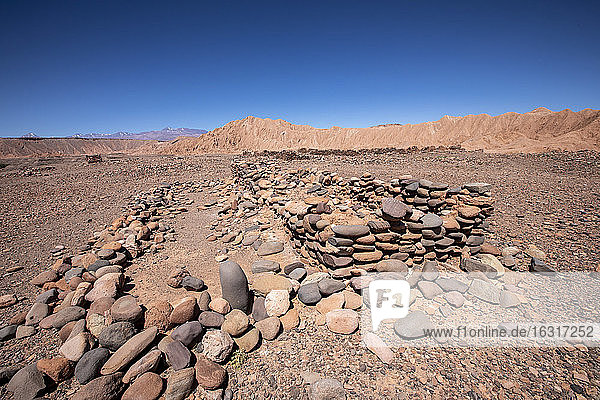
[0,151,600,399]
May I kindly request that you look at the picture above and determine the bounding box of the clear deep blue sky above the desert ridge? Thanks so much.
[0,0,600,136]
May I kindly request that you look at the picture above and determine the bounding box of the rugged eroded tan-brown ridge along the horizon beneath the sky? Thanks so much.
[143,107,600,154]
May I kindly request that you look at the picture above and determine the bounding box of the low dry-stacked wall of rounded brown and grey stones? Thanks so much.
[232,161,494,276]
